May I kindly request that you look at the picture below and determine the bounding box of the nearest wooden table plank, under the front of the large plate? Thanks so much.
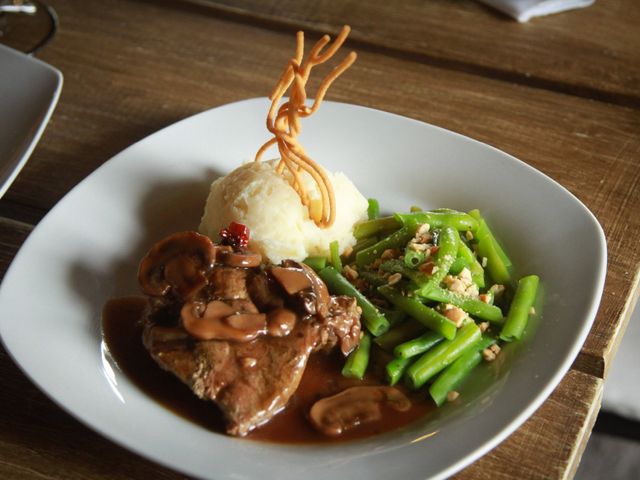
[0,336,602,480]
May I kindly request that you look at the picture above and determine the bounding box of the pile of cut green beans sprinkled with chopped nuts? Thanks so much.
[305,200,539,406]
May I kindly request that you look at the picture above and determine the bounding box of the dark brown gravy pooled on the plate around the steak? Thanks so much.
[102,297,434,443]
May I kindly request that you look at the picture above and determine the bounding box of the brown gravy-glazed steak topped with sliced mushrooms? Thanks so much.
[140,232,360,436]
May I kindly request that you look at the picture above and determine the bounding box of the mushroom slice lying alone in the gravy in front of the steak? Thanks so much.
[309,385,411,436]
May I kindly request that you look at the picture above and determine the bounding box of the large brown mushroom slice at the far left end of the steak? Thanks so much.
[138,232,216,300]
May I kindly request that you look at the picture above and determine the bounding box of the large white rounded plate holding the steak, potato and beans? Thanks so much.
[0,99,606,480]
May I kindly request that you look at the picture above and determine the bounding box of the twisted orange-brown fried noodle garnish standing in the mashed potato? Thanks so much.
[255,25,357,228]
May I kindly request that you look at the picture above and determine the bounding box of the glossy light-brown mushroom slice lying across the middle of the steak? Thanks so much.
[180,300,267,342]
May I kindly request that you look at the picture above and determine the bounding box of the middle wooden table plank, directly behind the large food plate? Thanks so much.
[0,0,640,376]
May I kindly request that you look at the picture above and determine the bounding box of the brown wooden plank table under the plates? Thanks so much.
[0,0,640,479]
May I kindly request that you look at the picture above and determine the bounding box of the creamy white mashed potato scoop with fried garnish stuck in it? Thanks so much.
[199,160,367,263]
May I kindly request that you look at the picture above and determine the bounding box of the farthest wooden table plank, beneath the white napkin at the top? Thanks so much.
[195,0,640,107]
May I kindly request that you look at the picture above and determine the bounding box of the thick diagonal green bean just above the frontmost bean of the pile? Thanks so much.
[405,322,481,389]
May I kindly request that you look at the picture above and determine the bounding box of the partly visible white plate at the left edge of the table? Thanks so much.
[0,45,62,197]
